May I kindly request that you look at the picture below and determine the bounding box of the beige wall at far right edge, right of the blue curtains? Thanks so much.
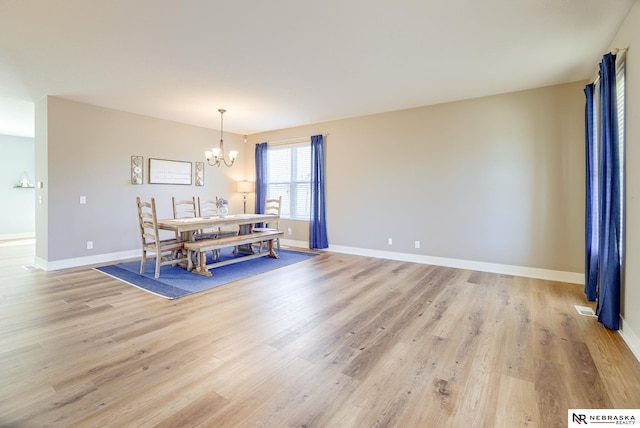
[610,2,640,358]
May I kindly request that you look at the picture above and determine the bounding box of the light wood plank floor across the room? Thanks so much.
[0,239,640,428]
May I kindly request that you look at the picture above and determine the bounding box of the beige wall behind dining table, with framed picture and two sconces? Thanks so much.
[36,97,245,266]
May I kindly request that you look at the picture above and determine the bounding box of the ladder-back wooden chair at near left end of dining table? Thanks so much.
[136,197,187,278]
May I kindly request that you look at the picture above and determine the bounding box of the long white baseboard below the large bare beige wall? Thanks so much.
[324,241,584,284]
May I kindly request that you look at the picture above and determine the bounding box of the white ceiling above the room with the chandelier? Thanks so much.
[0,0,635,136]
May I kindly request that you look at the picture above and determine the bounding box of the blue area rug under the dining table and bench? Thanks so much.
[95,248,317,299]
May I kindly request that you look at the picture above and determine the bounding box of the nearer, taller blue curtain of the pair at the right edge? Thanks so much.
[596,54,622,330]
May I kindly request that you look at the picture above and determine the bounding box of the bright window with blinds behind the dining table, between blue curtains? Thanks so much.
[267,144,311,220]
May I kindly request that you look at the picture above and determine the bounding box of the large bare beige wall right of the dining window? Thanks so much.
[246,83,584,273]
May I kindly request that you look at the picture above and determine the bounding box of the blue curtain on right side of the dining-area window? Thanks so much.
[309,135,329,249]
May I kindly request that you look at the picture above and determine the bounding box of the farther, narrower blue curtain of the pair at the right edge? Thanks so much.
[584,83,600,302]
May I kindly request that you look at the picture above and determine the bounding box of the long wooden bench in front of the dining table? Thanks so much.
[184,231,284,276]
